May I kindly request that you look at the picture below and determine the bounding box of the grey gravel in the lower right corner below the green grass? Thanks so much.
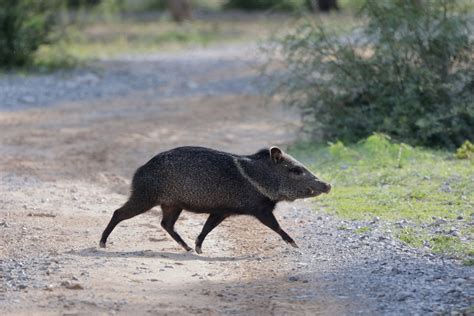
[294,208,474,315]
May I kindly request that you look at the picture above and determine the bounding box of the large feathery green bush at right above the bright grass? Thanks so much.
[277,0,474,148]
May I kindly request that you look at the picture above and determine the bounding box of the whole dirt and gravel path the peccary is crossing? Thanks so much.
[0,45,474,315]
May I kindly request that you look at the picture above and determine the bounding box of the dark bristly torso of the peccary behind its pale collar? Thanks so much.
[133,147,262,212]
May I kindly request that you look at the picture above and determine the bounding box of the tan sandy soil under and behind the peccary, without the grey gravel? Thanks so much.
[0,78,352,315]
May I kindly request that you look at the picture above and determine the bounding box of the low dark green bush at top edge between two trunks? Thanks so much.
[226,0,307,11]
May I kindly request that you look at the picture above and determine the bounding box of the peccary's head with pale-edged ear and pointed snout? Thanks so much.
[269,147,331,201]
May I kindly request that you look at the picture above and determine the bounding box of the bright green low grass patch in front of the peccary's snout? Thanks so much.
[289,134,474,257]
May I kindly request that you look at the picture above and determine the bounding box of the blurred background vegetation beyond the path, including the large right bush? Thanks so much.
[0,0,474,149]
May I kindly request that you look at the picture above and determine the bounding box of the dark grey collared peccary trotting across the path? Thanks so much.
[100,147,331,253]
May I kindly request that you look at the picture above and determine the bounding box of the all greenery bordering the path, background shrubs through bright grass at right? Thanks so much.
[0,0,474,264]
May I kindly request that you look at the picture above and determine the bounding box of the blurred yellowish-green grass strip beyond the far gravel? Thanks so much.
[44,11,314,61]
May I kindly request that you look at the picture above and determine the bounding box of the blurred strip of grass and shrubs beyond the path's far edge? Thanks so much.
[0,0,361,68]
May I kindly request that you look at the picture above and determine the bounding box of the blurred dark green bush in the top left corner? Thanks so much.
[0,0,58,67]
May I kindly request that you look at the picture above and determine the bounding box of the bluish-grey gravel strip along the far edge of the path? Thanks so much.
[0,45,262,111]
